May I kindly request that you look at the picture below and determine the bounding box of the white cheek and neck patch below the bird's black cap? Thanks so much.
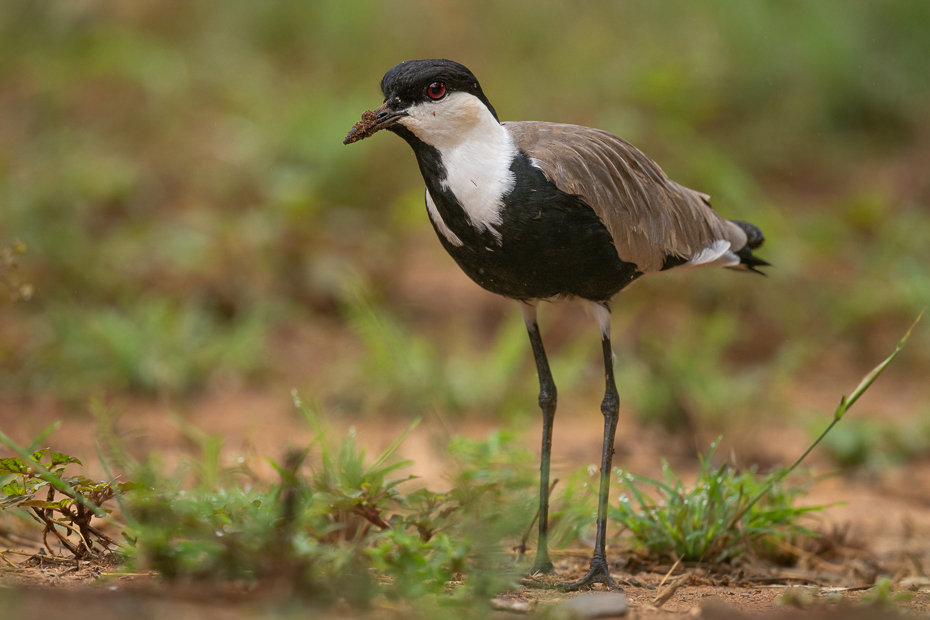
[399,93,517,243]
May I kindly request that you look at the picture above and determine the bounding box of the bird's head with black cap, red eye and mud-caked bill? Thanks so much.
[344,60,499,147]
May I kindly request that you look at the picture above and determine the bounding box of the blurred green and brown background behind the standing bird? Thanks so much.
[0,0,930,446]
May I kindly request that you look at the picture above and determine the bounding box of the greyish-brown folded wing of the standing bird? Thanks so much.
[504,121,746,273]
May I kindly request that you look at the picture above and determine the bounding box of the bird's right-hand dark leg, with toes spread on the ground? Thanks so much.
[562,304,620,590]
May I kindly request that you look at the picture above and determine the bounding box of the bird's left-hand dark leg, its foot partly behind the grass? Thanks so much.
[520,302,558,573]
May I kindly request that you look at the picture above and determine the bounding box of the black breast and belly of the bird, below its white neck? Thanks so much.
[426,155,639,301]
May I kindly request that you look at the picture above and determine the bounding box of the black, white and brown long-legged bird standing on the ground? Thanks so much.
[344,59,769,590]
